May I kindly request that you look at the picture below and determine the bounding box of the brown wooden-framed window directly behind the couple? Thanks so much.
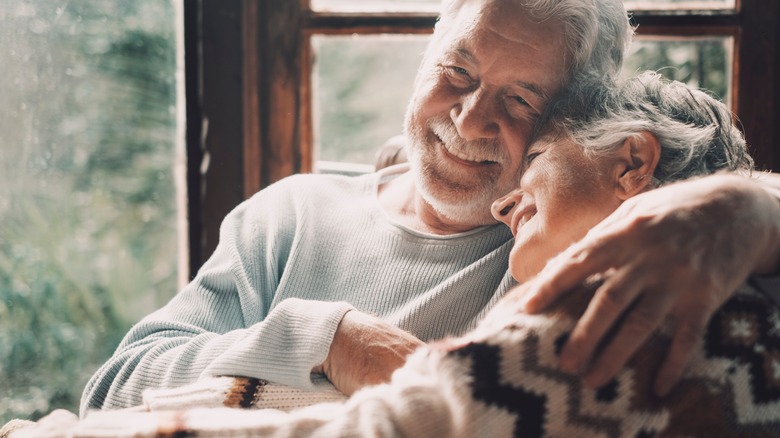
[185,0,780,269]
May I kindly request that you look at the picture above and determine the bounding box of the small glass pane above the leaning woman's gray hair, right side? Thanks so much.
[623,37,734,104]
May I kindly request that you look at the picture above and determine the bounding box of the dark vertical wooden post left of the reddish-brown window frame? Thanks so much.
[185,0,244,276]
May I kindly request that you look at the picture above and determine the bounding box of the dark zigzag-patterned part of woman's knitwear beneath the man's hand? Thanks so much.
[446,284,780,437]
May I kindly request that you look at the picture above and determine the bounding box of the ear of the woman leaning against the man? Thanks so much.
[615,131,661,201]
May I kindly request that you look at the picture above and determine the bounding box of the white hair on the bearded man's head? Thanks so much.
[436,0,633,81]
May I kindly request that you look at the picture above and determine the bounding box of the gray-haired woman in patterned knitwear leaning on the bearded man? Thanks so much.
[12,73,780,438]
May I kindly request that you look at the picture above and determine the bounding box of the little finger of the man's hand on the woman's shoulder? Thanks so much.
[654,314,708,397]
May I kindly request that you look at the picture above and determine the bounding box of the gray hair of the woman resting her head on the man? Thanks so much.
[539,72,753,184]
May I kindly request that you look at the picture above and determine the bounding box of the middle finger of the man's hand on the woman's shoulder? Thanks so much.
[560,269,643,372]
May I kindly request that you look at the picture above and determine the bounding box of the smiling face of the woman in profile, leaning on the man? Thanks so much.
[491,134,622,281]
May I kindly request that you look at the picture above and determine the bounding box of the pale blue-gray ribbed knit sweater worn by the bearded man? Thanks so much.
[81,166,515,414]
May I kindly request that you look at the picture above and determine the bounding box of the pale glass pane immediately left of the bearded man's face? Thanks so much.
[312,35,429,170]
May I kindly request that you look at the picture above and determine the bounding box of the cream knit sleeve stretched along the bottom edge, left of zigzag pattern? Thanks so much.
[64,348,478,438]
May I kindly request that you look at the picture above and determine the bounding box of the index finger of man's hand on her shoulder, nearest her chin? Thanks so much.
[521,241,617,313]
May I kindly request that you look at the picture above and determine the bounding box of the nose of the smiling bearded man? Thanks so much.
[451,88,499,140]
